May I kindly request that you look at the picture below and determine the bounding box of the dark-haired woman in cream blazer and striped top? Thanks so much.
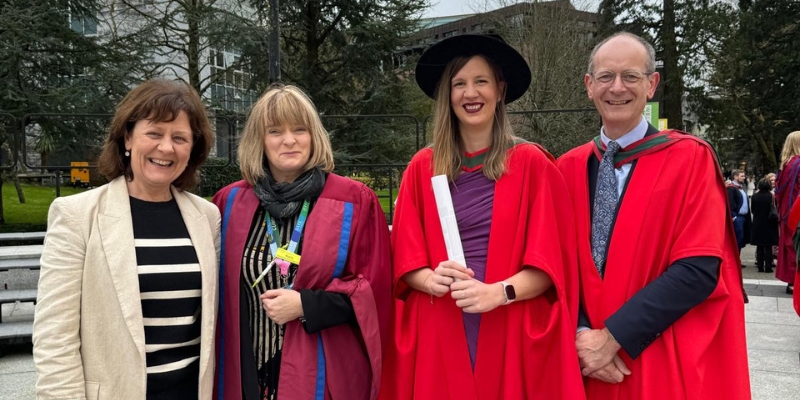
[33,79,220,400]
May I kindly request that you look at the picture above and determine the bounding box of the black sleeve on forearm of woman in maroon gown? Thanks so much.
[300,289,356,333]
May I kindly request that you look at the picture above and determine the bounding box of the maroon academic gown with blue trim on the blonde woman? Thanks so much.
[213,174,392,400]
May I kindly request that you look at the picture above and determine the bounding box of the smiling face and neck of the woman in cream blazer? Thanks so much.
[125,111,194,201]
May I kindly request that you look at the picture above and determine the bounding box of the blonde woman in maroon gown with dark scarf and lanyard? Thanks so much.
[214,86,391,400]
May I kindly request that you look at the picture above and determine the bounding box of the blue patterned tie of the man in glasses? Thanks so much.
[592,140,620,278]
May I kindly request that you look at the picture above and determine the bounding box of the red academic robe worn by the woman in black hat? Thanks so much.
[381,143,584,400]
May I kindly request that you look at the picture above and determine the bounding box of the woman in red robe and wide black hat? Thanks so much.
[381,35,584,400]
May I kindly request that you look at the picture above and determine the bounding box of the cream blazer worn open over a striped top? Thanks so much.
[33,177,220,400]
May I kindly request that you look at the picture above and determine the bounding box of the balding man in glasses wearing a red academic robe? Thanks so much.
[558,33,750,400]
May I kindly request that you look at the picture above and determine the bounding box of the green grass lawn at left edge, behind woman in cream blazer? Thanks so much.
[0,181,86,232]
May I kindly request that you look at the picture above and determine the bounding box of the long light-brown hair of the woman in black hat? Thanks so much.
[433,55,514,182]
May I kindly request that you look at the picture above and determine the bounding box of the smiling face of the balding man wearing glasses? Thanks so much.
[584,36,660,139]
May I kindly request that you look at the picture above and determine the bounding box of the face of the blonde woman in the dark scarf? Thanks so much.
[264,124,311,182]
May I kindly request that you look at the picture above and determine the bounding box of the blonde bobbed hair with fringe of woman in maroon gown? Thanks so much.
[238,85,334,185]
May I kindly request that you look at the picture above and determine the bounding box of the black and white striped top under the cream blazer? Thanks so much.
[130,197,202,399]
